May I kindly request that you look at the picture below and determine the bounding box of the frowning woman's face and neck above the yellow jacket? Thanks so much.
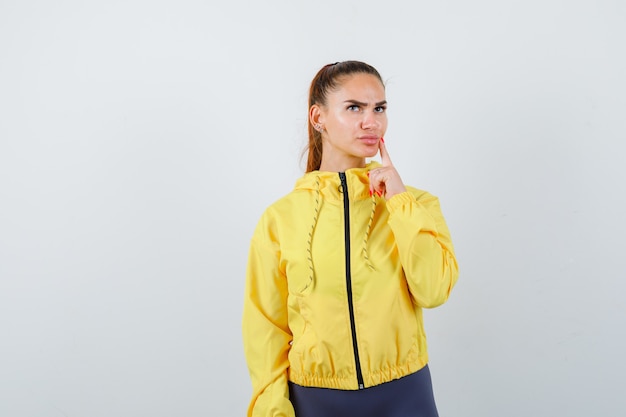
[311,73,387,171]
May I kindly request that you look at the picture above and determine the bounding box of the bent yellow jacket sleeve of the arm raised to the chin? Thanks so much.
[387,187,459,308]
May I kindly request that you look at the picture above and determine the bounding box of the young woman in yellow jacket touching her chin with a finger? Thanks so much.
[243,61,458,417]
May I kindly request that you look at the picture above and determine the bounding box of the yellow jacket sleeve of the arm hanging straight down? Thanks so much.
[242,214,295,417]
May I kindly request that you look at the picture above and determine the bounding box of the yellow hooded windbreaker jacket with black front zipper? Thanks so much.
[242,162,458,417]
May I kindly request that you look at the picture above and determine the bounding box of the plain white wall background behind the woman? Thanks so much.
[0,0,626,417]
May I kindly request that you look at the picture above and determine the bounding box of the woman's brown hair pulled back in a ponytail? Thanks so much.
[305,61,385,172]
